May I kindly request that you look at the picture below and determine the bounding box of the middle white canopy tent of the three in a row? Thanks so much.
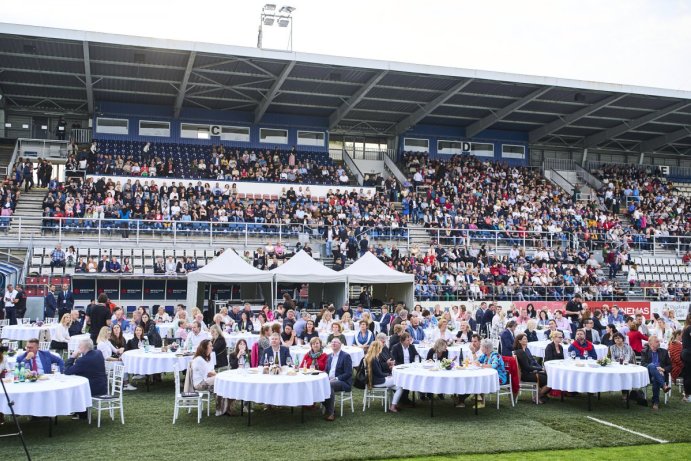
[270,250,346,307]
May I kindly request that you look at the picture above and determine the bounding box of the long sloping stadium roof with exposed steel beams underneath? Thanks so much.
[0,23,691,154]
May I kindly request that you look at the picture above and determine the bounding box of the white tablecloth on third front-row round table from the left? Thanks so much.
[393,365,499,394]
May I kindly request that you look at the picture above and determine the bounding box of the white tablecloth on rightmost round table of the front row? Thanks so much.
[545,360,650,393]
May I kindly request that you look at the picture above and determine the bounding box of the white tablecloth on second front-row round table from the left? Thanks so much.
[214,368,331,407]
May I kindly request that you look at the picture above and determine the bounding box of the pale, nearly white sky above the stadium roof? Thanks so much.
[0,0,691,91]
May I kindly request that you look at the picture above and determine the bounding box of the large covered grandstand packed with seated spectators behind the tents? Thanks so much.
[0,24,691,316]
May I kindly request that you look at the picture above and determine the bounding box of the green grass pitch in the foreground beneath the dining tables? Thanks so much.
[0,375,691,461]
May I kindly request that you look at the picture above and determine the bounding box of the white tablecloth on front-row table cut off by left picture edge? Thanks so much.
[0,375,91,418]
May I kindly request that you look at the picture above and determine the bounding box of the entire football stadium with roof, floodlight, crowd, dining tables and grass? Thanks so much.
[0,4,691,460]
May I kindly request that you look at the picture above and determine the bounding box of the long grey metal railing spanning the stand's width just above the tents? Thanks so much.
[0,216,691,255]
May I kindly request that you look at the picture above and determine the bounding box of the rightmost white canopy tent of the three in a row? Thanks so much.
[340,251,415,309]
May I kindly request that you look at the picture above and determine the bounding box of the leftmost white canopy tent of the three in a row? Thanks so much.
[187,249,273,311]
